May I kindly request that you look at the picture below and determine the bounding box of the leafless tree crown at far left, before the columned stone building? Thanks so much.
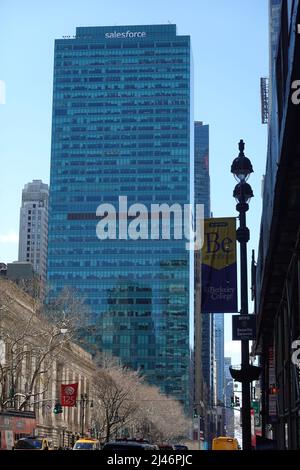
[0,281,86,410]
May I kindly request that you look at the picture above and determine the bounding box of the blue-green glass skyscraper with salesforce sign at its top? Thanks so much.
[48,25,194,404]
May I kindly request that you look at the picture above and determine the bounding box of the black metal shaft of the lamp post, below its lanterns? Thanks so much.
[238,201,251,450]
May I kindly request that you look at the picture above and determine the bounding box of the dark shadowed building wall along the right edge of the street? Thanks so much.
[256,0,300,449]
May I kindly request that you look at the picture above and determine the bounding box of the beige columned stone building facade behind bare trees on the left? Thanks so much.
[0,279,95,447]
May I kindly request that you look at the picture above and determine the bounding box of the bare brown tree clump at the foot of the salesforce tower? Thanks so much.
[92,354,189,442]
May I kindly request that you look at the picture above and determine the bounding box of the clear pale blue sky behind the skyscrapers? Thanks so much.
[0,0,268,362]
